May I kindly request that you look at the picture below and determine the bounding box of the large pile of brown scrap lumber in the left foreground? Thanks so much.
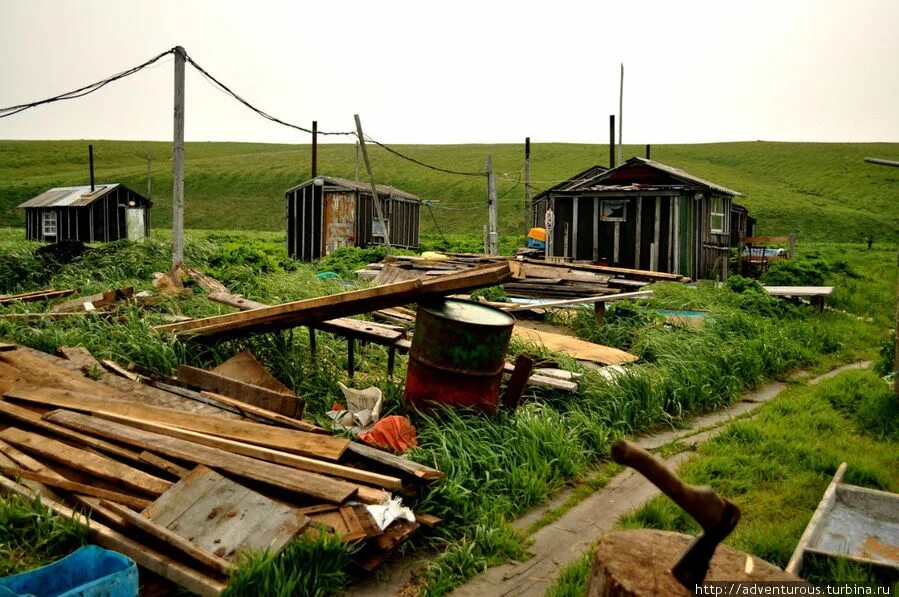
[0,344,442,595]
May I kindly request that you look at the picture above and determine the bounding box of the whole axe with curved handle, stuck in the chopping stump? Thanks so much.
[612,440,740,591]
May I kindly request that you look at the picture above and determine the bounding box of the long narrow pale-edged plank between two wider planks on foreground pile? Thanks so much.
[92,414,403,489]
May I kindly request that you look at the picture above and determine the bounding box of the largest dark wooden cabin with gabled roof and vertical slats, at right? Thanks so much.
[533,157,753,279]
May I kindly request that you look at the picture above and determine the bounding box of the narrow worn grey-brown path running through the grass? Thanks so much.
[348,363,869,597]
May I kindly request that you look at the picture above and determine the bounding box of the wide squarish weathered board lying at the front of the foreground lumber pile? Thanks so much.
[143,466,308,562]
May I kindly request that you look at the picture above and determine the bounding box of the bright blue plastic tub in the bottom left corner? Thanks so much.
[0,545,138,597]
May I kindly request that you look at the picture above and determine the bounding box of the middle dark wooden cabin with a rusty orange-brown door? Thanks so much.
[285,176,421,261]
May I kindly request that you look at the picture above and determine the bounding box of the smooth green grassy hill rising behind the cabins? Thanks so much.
[0,141,899,242]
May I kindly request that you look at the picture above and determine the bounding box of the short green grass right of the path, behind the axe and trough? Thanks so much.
[547,371,899,597]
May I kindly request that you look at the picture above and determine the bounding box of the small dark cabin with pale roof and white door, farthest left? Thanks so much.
[19,183,152,243]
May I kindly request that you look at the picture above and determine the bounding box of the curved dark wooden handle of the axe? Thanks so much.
[612,439,726,532]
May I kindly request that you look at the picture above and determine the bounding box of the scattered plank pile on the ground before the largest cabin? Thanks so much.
[356,253,687,299]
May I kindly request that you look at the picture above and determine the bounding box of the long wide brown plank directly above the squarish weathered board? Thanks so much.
[47,411,358,504]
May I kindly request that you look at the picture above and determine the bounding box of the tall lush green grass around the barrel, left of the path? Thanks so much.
[0,230,891,595]
